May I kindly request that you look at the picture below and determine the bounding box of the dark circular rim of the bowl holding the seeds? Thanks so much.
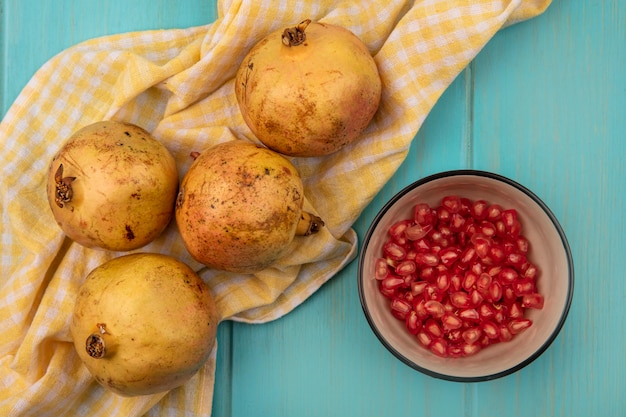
[357,169,574,382]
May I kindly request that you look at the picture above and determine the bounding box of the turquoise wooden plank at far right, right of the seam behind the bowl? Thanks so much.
[474,1,626,416]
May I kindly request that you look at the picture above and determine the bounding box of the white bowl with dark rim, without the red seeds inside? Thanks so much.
[358,170,574,382]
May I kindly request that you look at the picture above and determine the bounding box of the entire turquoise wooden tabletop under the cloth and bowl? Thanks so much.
[0,0,626,417]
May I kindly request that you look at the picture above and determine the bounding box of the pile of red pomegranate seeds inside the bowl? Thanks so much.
[375,195,543,358]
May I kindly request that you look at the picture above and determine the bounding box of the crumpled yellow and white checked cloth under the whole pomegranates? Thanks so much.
[0,0,550,417]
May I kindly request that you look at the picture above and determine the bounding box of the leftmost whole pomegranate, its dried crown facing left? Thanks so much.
[47,121,178,251]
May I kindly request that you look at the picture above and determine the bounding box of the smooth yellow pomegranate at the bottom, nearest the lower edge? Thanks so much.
[70,253,220,396]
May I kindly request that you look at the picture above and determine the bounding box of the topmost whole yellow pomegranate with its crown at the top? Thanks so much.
[235,19,382,157]
